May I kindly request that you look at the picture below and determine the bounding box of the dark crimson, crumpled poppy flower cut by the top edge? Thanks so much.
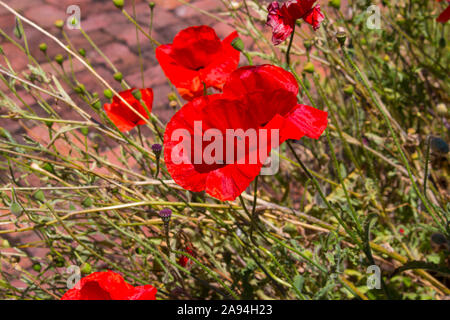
[267,0,325,45]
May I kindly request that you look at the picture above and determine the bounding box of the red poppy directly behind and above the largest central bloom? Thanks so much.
[156,26,240,100]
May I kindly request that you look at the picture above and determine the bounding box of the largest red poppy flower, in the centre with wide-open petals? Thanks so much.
[164,65,327,201]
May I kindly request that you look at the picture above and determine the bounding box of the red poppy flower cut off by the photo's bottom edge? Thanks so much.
[61,271,157,300]
